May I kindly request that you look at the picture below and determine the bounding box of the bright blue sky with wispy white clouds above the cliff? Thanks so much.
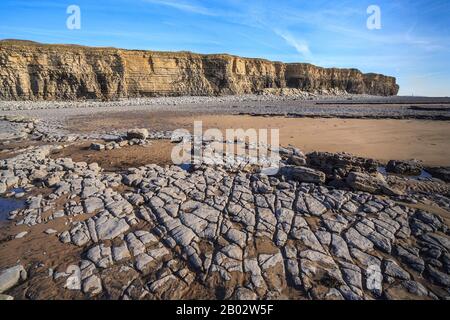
[0,0,450,96]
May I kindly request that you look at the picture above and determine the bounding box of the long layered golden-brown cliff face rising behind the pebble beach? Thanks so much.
[0,41,398,100]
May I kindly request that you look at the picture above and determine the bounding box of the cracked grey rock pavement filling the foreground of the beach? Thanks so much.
[0,110,450,300]
